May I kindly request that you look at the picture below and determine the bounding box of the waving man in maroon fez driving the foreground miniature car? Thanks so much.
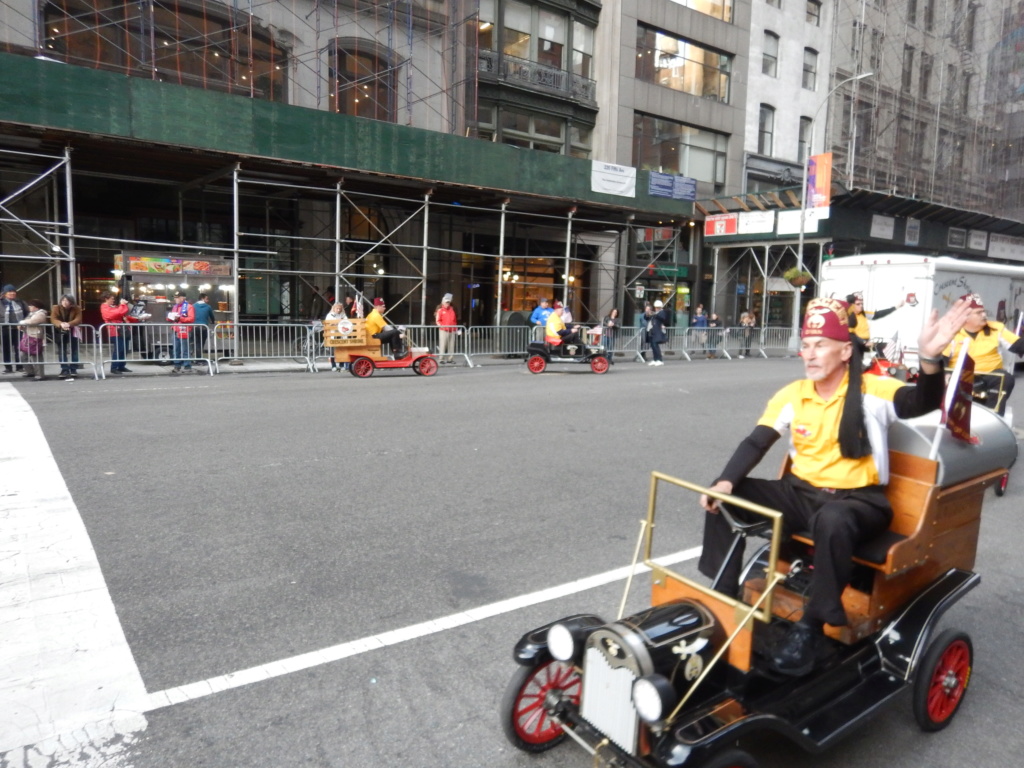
[698,299,968,676]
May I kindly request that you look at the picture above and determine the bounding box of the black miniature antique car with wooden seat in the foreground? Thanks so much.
[501,410,1017,768]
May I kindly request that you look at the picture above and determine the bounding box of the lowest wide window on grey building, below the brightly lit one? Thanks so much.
[633,113,729,190]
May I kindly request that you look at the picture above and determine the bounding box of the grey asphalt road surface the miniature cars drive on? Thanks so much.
[0,359,1024,768]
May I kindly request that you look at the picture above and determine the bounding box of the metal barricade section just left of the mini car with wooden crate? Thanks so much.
[213,321,315,372]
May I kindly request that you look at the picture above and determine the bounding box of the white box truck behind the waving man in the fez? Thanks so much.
[818,253,1024,370]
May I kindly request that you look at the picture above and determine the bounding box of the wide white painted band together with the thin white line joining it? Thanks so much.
[0,384,700,749]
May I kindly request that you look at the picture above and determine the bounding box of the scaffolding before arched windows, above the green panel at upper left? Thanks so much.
[0,0,479,134]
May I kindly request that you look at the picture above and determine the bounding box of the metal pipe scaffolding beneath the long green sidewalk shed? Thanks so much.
[0,150,689,325]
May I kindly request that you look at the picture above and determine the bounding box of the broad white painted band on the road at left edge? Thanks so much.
[0,384,147,765]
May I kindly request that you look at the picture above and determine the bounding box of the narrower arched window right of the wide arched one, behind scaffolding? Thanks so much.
[330,40,395,123]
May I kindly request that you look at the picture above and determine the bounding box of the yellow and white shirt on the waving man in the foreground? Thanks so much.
[758,375,904,488]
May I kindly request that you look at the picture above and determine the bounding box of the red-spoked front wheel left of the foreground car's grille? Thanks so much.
[501,660,583,753]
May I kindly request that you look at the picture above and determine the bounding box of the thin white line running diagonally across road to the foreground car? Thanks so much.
[145,547,700,712]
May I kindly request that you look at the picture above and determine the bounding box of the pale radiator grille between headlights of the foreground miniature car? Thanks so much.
[580,646,639,755]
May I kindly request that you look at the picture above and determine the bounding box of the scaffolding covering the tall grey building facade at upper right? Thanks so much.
[826,0,1006,214]
